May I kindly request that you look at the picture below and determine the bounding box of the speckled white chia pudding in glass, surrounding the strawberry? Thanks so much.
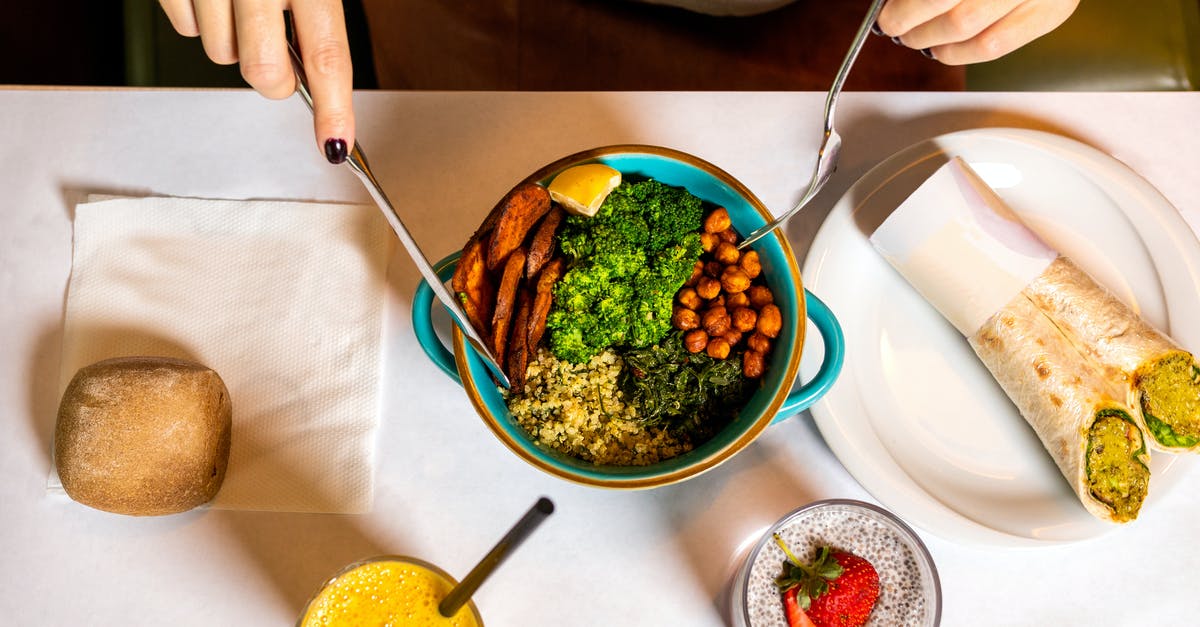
[732,500,942,627]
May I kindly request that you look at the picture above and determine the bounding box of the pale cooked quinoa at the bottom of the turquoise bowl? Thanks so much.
[508,348,691,466]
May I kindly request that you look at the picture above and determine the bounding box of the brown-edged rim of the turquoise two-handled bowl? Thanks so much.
[451,144,808,490]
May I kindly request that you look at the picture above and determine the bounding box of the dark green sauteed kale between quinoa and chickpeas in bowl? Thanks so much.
[619,332,757,442]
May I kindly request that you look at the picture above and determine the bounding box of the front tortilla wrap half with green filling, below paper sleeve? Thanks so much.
[968,294,1150,523]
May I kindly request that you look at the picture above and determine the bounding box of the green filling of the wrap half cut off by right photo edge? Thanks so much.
[1134,352,1200,448]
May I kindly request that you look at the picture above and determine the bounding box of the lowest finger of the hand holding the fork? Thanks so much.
[932,1,1078,65]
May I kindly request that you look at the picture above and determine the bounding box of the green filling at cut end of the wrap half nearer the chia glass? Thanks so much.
[1086,410,1150,523]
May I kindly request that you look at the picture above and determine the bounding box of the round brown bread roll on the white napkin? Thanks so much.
[54,357,232,515]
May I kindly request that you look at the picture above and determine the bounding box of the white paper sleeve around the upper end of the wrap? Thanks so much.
[871,157,1058,338]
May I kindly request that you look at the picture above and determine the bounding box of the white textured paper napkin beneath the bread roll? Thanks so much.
[50,198,392,513]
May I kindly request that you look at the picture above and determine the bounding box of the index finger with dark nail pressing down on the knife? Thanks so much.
[292,0,354,163]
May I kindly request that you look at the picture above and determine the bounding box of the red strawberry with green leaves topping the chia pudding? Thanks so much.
[775,533,880,627]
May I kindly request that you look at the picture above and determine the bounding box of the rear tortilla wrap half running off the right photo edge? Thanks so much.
[1024,257,1200,453]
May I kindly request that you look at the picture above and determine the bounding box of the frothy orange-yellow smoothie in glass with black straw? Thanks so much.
[296,555,484,627]
